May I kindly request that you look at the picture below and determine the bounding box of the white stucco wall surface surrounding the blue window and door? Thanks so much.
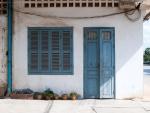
[13,2,143,99]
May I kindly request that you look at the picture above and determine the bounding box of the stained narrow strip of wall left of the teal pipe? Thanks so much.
[0,16,7,82]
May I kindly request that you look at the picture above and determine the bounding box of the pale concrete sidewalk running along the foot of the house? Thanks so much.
[0,99,150,113]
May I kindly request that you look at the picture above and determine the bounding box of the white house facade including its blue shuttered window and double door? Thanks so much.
[0,0,146,99]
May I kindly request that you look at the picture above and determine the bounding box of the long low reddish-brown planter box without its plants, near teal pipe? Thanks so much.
[10,93,33,100]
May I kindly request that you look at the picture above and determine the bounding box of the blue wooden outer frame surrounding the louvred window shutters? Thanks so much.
[27,27,74,75]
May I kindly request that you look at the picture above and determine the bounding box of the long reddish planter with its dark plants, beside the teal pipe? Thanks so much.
[10,89,33,99]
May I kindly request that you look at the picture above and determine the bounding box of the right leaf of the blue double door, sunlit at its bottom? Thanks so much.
[100,28,115,98]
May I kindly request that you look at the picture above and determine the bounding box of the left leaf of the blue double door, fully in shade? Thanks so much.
[84,29,99,98]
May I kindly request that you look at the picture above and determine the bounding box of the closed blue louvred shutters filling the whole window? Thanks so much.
[28,28,73,75]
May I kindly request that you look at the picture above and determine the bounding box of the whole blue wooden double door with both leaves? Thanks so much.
[84,28,115,98]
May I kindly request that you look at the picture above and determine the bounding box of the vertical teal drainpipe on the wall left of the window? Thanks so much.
[7,0,13,95]
